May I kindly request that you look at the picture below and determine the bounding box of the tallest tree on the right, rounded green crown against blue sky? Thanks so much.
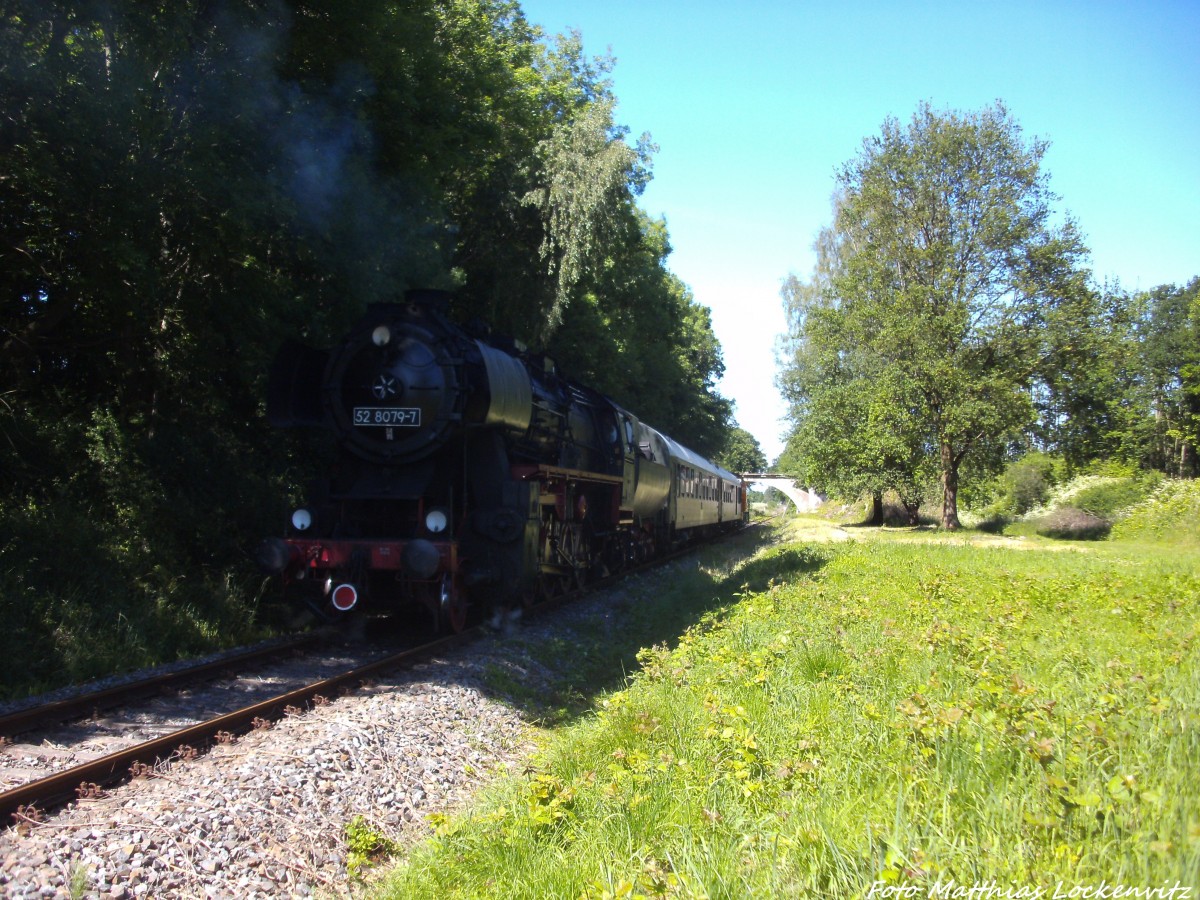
[782,102,1087,529]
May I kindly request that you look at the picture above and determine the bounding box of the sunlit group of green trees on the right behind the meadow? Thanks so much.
[779,103,1200,529]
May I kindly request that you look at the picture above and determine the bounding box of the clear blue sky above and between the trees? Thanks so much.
[521,0,1200,458]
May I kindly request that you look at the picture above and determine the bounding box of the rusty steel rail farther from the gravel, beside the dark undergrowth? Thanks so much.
[0,634,324,738]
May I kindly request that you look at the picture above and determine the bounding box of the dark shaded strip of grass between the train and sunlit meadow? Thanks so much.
[472,529,828,726]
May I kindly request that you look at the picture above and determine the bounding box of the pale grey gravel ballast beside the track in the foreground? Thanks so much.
[0,638,529,898]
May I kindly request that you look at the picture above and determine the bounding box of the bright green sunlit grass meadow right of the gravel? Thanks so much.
[376,521,1200,899]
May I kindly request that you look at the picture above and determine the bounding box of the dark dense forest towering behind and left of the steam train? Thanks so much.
[0,0,733,696]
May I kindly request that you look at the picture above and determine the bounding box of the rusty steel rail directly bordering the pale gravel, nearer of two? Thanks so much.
[0,630,468,821]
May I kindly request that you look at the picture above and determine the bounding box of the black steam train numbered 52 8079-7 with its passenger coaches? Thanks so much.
[258,292,746,631]
